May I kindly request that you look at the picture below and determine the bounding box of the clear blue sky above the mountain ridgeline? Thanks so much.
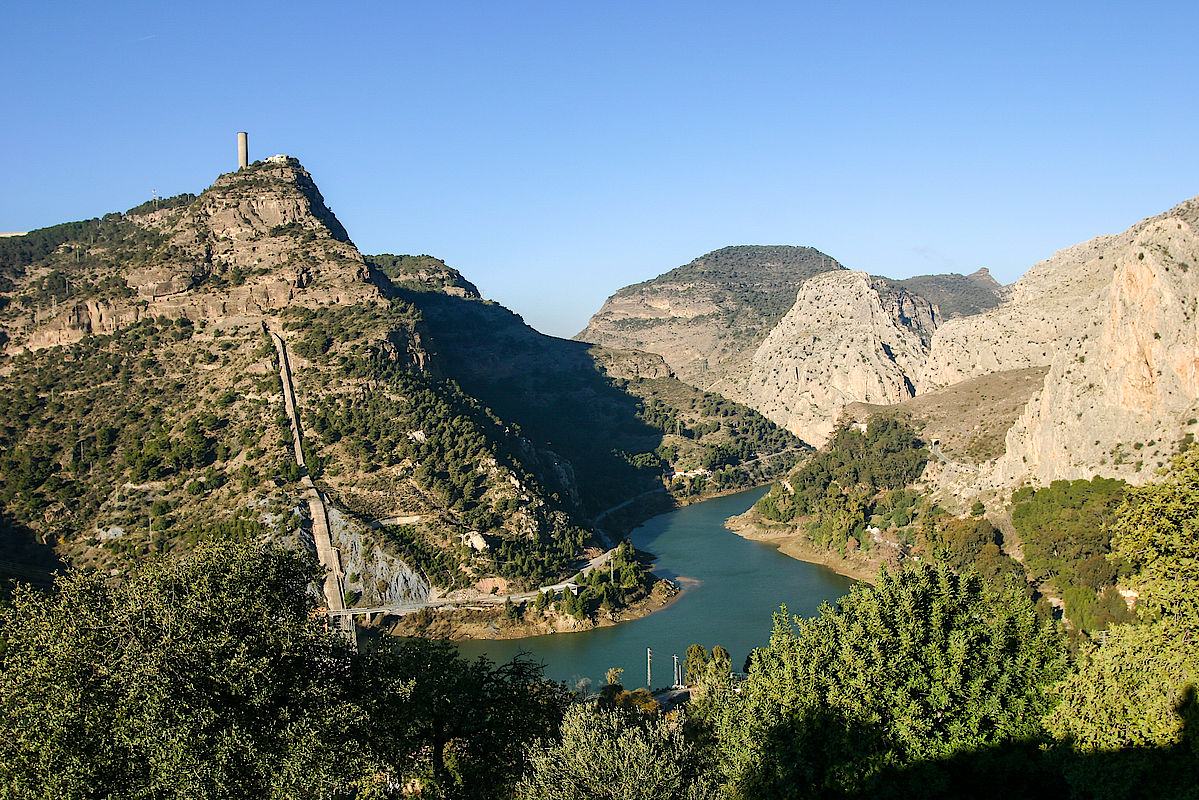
[0,0,1199,336]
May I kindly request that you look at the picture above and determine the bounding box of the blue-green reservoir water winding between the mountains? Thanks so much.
[459,488,854,688]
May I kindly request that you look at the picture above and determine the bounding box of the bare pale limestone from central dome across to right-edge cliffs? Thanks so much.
[737,200,1199,495]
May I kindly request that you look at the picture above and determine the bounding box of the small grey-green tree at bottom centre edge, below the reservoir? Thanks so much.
[518,705,715,800]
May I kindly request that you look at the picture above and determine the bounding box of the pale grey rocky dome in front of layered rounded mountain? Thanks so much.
[734,270,938,444]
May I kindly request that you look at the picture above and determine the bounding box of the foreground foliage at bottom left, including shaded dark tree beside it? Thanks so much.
[0,543,567,800]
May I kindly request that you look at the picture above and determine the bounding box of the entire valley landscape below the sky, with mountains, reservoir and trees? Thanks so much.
[0,156,1199,798]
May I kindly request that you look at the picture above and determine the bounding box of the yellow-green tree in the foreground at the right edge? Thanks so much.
[1048,447,1199,798]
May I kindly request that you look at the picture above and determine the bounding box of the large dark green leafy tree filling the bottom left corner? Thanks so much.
[0,543,366,798]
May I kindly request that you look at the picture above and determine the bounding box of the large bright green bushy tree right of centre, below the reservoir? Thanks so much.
[715,565,1066,798]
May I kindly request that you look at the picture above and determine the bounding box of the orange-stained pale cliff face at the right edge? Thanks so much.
[988,198,1199,486]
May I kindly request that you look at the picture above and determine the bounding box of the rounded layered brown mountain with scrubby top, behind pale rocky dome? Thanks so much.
[574,245,844,393]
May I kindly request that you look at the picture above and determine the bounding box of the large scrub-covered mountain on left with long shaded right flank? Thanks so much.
[0,156,802,606]
